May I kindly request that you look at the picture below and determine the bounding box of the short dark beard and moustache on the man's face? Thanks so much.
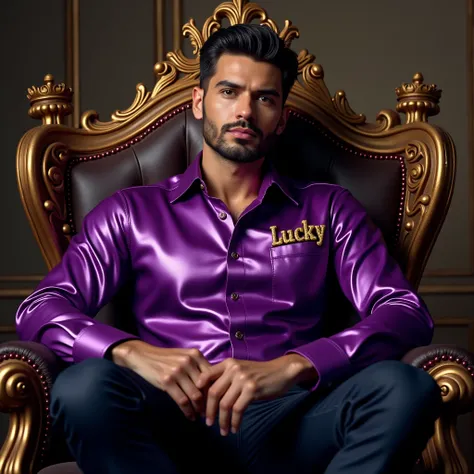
[203,107,278,163]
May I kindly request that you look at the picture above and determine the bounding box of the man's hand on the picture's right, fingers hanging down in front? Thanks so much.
[196,354,317,436]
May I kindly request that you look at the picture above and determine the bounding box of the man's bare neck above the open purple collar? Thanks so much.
[201,143,264,208]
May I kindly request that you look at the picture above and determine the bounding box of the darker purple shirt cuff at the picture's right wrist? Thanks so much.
[286,338,351,391]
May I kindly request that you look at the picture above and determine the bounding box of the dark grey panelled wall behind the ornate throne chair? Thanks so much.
[0,0,474,468]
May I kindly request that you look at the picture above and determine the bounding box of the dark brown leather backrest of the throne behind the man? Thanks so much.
[70,108,404,333]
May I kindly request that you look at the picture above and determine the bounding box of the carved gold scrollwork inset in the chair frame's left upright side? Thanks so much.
[42,142,71,234]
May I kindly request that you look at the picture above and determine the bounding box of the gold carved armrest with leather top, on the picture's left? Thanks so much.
[0,341,61,474]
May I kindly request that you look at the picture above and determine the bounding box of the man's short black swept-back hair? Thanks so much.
[199,23,298,103]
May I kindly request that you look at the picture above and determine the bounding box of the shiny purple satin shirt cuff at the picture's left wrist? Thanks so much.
[72,323,138,363]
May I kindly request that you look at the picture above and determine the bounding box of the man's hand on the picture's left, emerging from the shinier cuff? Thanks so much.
[111,340,211,420]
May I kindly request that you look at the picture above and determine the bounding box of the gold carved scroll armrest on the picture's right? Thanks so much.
[403,344,474,474]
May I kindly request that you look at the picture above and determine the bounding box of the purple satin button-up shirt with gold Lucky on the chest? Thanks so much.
[16,154,433,389]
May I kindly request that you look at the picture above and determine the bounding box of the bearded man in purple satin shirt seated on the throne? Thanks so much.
[17,25,441,474]
